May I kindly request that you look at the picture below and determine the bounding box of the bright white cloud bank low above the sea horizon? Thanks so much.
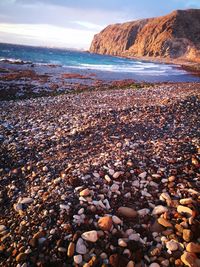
[0,23,95,49]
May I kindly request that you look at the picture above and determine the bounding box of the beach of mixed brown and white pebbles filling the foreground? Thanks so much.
[0,78,200,267]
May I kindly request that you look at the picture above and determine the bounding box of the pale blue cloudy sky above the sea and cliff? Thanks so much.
[0,0,200,49]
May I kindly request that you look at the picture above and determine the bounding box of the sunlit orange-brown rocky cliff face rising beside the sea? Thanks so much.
[90,9,200,62]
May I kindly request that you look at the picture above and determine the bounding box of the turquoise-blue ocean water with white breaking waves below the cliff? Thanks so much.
[0,44,200,82]
